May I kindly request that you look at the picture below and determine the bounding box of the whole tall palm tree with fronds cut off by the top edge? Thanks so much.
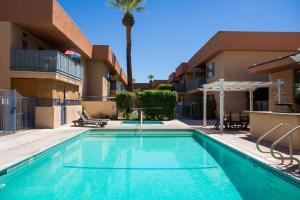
[108,0,145,91]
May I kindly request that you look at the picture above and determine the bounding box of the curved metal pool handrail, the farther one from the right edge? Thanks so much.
[256,123,293,164]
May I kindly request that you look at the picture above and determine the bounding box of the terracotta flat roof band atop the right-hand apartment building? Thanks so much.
[189,31,300,70]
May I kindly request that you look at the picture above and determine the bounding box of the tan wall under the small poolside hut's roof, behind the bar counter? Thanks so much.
[269,69,294,110]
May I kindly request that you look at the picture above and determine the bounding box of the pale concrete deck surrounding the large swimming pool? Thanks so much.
[0,120,300,180]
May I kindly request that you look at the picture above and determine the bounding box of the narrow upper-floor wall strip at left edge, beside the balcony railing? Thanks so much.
[0,22,11,90]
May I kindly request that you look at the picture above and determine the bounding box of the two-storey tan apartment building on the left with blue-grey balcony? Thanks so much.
[0,0,127,128]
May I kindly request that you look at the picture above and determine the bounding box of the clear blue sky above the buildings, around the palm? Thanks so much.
[58,0,300,82]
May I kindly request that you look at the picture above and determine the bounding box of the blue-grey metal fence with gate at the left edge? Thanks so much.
[0,90,36,133]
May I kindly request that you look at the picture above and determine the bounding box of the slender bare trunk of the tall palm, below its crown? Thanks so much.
[126,27,133,92]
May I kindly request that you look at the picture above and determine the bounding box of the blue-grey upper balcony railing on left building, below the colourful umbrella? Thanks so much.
[11,49,83,80]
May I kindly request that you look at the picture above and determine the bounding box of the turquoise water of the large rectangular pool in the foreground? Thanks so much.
[0,131,300,200]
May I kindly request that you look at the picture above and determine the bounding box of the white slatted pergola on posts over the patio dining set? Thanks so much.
[201,79,284,132]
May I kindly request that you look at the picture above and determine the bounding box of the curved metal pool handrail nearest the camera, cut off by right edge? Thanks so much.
[271,126,300,170]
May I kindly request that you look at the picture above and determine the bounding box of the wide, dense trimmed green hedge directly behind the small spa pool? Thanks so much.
[137,90,178,120]
